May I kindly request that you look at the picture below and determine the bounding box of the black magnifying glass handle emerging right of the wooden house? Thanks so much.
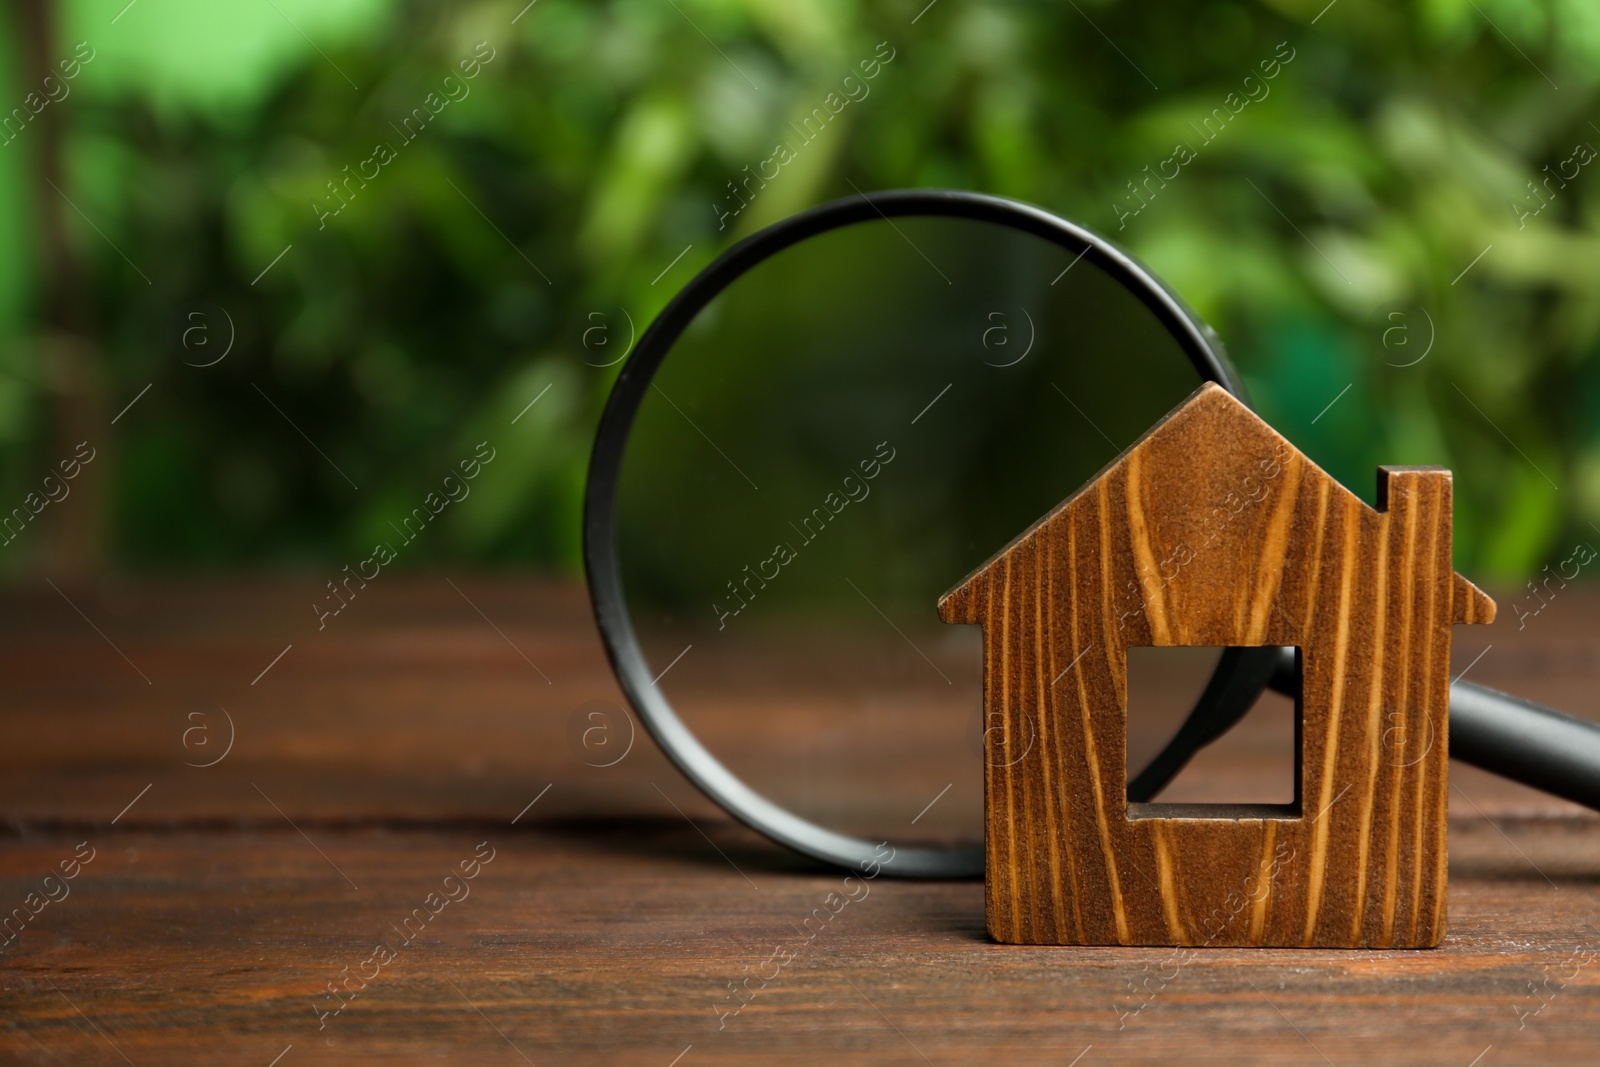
[1270,649,1600,811]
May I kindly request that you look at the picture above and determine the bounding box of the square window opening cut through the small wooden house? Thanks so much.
[1126,646,1301,819]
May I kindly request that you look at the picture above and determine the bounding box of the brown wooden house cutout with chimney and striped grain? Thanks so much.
[939,386,1494,947]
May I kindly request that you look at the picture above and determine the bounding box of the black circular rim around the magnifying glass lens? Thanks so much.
[584,189,1248,878]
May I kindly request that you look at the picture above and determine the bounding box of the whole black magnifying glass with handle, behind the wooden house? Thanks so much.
[584,190,1600,878]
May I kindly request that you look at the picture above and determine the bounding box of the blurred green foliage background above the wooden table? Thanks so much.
[0,0,1600,579]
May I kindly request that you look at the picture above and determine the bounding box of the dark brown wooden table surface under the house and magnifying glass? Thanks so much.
[0,576,1600,1067]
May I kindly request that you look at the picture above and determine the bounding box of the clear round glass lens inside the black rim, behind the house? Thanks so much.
[616,216,1222,845]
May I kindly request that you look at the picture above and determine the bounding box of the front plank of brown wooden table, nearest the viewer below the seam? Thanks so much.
[9,819,1600,1067]
